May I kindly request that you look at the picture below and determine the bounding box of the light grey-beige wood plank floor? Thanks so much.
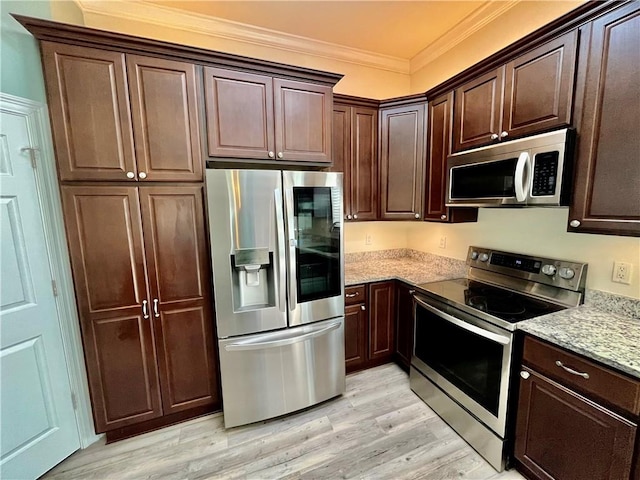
[43,364,523,480]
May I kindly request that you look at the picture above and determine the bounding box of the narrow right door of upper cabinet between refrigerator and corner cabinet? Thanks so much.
[349,107,379,220]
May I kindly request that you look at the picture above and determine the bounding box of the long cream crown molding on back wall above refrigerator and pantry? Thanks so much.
[76,0,410,75]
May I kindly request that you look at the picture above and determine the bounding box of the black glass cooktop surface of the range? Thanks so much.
[419,278,566,329]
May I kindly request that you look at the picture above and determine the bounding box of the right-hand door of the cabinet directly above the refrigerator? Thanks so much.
[273,79,333,163]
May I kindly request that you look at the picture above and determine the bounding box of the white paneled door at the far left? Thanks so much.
[0,100,80,479]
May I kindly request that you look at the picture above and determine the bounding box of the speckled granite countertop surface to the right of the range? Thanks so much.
[518,305,640,378]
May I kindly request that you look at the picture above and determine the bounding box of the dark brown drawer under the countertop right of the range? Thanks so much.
[523,337,640,415]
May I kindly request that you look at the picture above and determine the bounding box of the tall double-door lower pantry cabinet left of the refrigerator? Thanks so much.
[62,185,220,439]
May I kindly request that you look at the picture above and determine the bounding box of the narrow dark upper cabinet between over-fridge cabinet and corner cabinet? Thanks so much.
[331,97,379,221]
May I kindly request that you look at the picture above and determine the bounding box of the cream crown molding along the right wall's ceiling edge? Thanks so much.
[410,0,521,73]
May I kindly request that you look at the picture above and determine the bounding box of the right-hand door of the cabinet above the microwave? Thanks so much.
[502,30,578,138]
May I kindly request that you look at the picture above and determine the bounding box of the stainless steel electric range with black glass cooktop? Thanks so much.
[410,247,587,471]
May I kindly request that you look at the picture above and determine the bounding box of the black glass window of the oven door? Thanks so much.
[415,306,504,416]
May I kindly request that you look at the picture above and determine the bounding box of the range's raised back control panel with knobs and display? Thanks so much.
[467,247,587,291]
